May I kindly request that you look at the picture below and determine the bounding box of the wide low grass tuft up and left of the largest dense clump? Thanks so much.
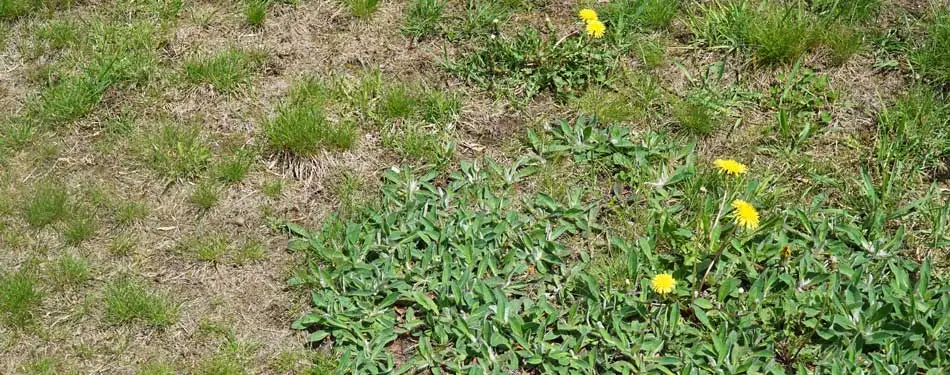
[185,48,264,93]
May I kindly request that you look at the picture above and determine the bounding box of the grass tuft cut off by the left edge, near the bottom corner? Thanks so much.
[0,270,43,327]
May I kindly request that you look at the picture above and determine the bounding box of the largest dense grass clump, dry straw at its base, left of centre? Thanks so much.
[264,78,357,155]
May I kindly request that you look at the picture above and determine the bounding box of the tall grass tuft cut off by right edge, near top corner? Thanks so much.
[910,10,950,85]
